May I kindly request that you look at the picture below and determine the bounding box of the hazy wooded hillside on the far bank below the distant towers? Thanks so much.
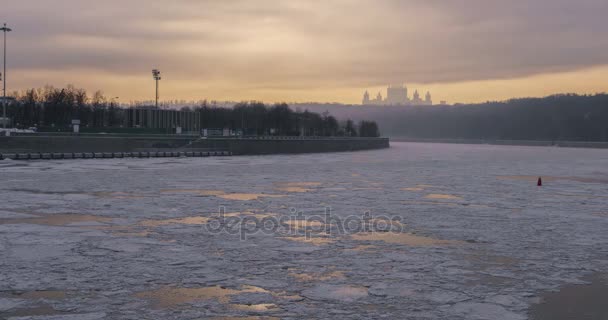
[292,93,608,141]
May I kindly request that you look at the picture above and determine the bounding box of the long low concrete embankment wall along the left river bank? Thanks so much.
[0,135,389,155]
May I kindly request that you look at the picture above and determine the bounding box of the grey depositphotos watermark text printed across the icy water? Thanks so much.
[205,206,404,240]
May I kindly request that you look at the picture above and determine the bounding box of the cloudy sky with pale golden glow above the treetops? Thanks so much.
[0,0,608,103]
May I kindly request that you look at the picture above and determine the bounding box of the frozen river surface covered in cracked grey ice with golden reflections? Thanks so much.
[0,143,608,320]
